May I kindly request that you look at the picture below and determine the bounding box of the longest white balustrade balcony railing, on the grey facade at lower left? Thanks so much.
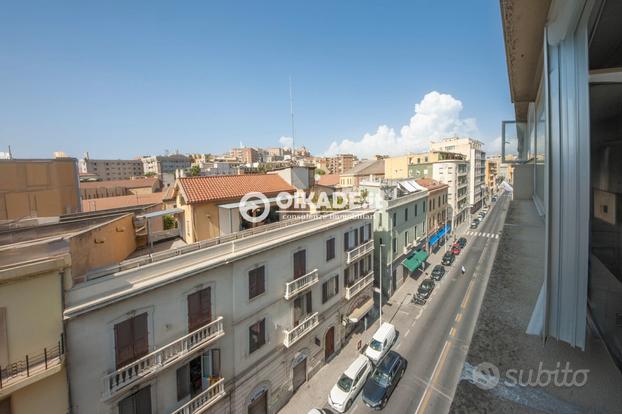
[104,316,225,397]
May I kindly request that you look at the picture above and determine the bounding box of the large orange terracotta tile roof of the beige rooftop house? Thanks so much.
[177,174,296,204]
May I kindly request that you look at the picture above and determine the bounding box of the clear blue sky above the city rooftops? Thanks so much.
[0,0,513,158]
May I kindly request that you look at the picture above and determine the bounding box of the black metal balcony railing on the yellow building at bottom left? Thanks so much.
[0,334,65,389]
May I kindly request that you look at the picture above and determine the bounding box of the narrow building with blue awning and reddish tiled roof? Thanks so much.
[415,178,453,250]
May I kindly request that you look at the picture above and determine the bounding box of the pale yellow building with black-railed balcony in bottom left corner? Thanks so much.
[0,254,70,414]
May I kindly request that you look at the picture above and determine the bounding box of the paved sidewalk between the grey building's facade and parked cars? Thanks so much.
[279,222,468,414]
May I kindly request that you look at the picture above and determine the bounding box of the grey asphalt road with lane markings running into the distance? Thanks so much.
[350,195,509,414]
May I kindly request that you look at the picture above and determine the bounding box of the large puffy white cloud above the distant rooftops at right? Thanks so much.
[325,91,478,158]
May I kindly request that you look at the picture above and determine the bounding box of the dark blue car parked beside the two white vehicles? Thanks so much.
[363,351,408,410]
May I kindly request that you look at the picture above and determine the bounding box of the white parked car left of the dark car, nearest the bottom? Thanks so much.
[328,355,372,413]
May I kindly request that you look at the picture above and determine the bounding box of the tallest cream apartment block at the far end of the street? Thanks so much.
[430,137,486,213]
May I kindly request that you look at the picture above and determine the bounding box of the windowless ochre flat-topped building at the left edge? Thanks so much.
[0,158,80,221]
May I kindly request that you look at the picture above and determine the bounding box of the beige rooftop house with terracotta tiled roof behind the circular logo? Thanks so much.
[174,169,296,243]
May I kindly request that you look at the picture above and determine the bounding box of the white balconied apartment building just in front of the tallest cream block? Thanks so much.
[432,160,470,228]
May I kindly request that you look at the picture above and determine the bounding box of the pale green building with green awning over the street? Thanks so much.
[360,180,428,297]
